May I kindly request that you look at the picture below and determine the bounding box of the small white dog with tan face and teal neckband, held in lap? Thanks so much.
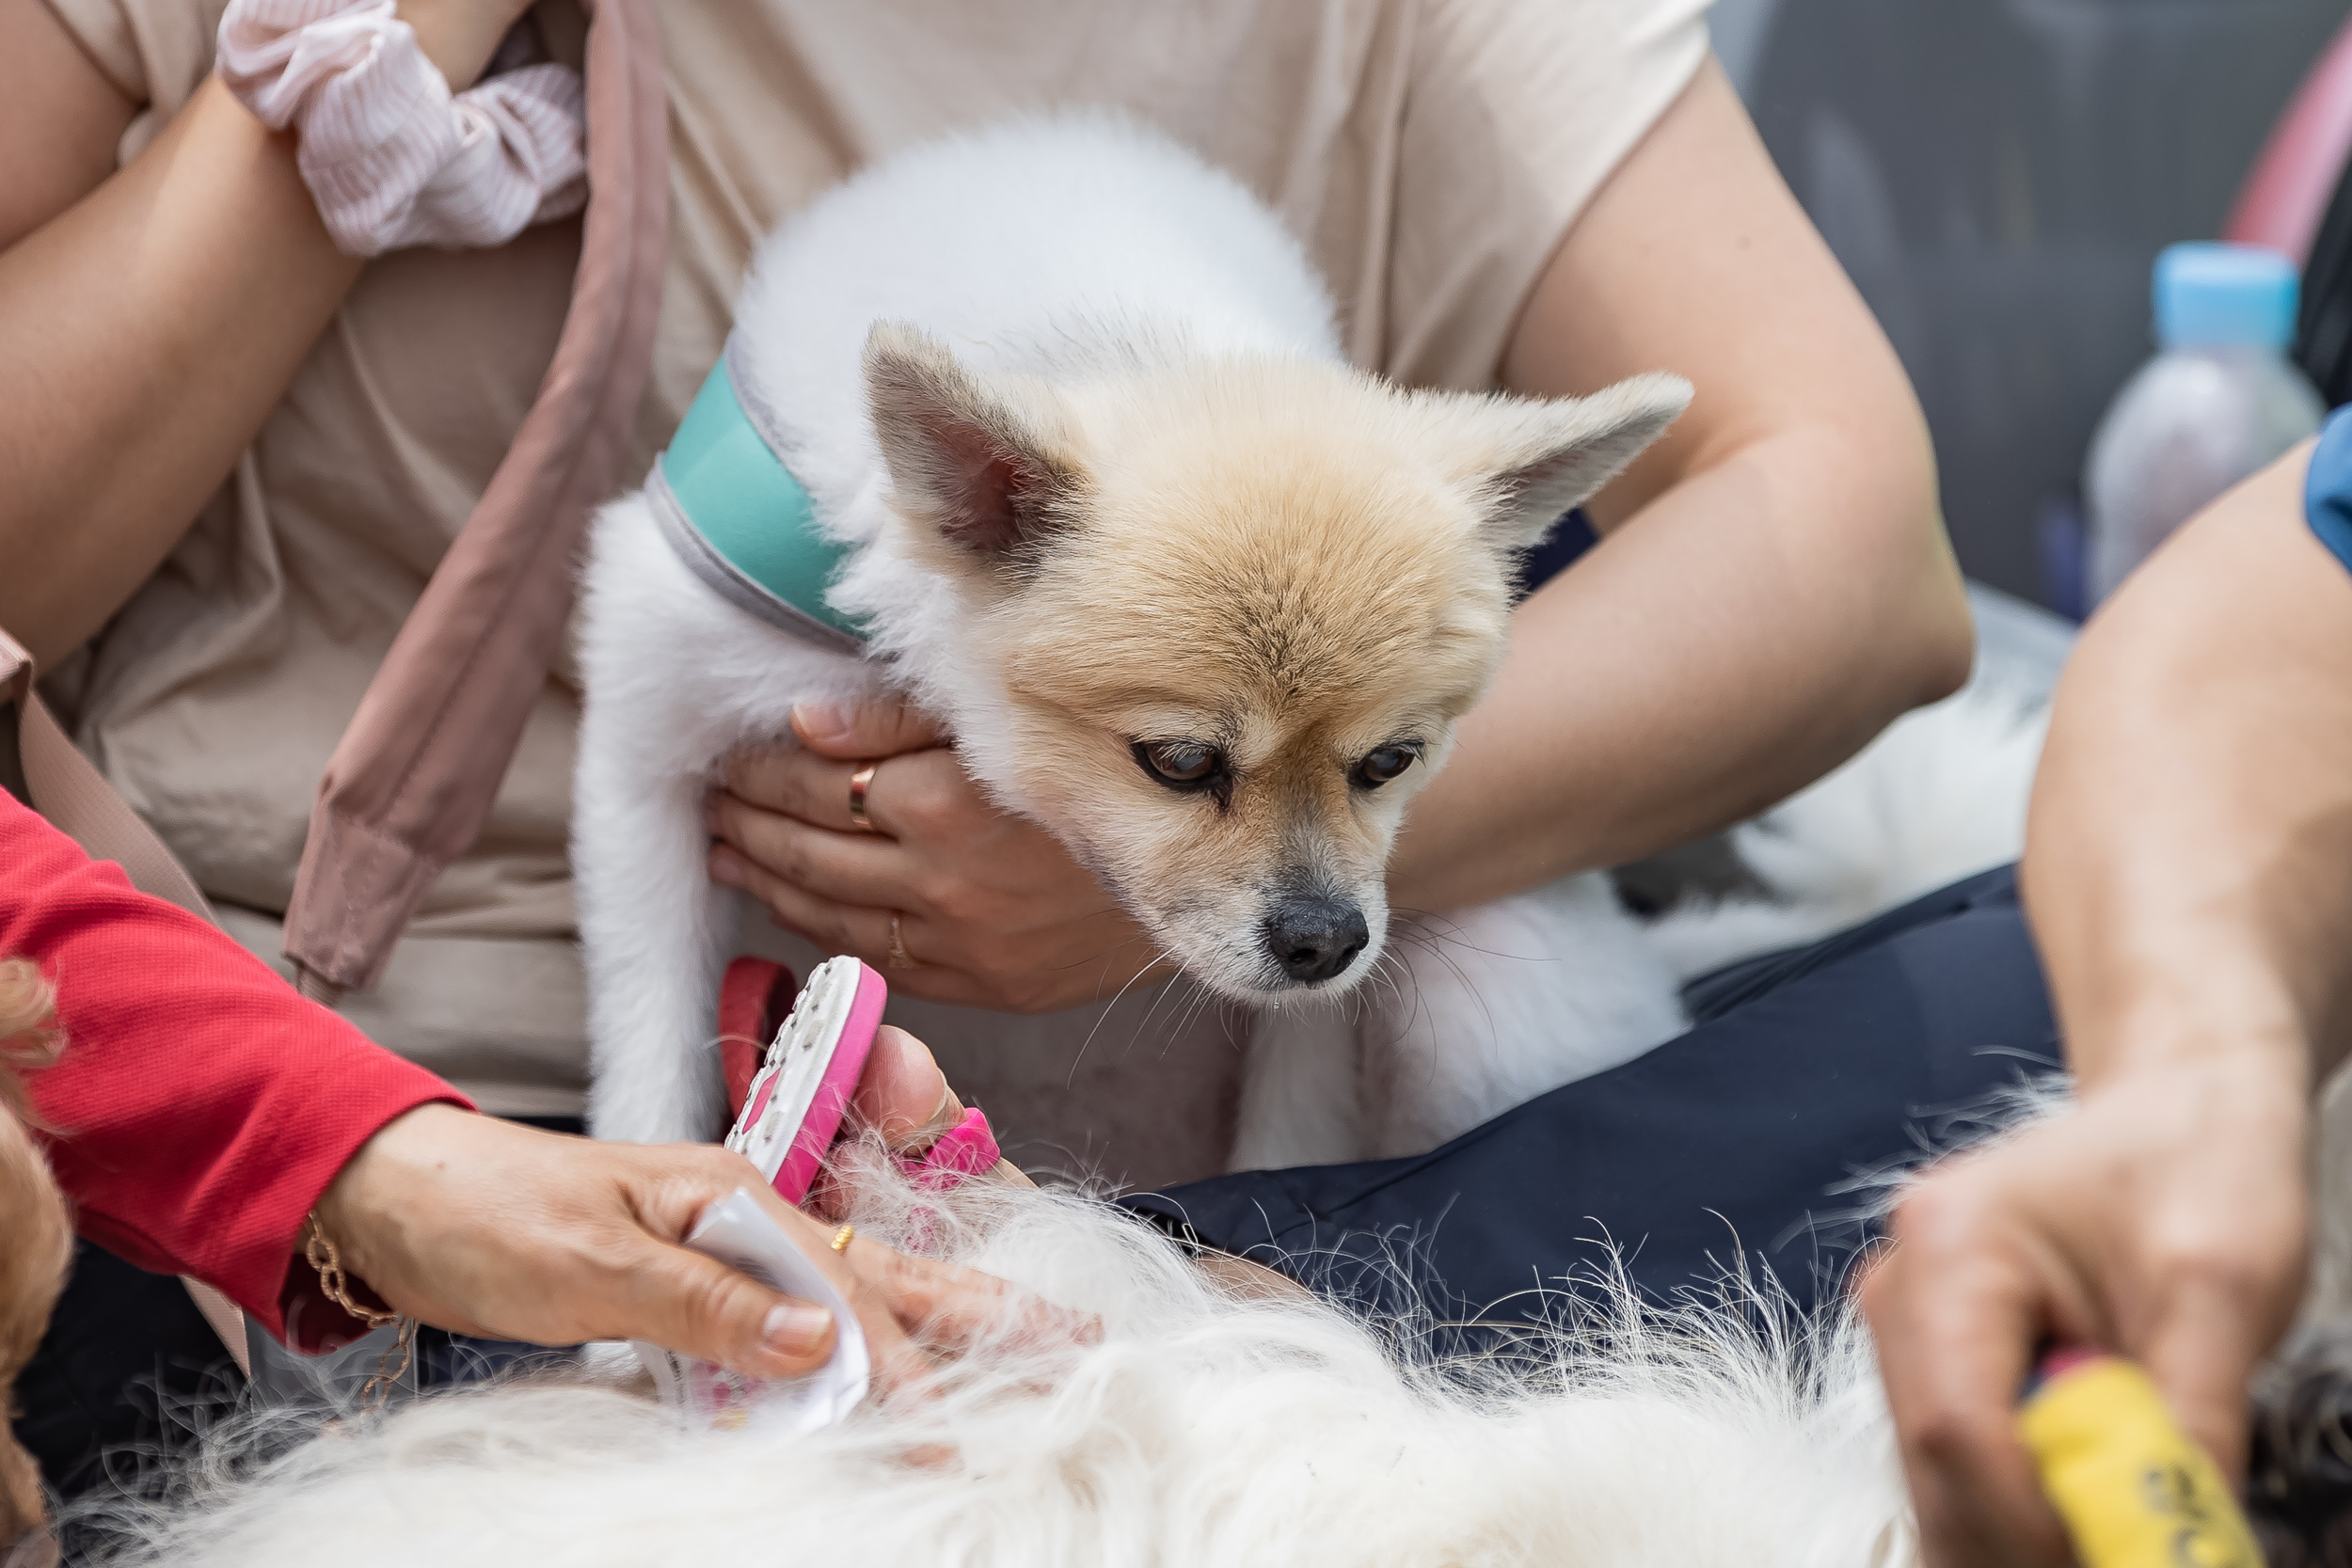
[574,115,1689,1159]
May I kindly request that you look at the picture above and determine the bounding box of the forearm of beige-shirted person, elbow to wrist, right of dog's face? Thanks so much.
[1391,430,1971,910]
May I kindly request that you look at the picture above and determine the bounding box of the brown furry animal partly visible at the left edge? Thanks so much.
[0,959,73,1561]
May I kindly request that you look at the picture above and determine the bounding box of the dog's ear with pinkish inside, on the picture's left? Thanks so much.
[866,322,1080,564]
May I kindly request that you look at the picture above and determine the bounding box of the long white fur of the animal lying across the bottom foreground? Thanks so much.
[91,1165,1915,1568]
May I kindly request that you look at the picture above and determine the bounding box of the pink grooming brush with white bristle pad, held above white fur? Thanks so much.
[727,957,1000,1206]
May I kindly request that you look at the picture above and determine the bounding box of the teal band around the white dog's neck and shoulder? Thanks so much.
[647,336,866,654]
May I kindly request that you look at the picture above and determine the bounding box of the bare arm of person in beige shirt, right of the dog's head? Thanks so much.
[1391,61,1971,910]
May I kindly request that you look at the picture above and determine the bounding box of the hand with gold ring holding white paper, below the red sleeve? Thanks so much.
[317,1105,1058,1387]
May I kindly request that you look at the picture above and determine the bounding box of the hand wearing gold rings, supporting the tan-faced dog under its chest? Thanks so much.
[708,701,1165,1013]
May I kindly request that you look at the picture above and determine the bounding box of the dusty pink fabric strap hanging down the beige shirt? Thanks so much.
[285,0,671,1002]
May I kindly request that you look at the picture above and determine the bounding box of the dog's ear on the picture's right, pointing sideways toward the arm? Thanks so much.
[1430,372,1692,550]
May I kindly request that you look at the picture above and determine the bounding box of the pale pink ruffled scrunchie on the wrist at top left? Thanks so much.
[219,0,588,256]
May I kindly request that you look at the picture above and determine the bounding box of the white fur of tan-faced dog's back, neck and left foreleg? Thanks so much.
[574,107,1341,1140]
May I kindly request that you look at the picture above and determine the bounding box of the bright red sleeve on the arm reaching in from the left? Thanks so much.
[0,792,469,1350]
